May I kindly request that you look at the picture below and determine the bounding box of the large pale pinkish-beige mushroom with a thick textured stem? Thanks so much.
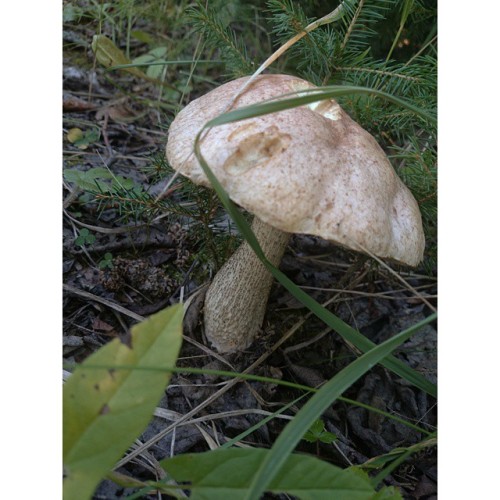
[166,75,425,353]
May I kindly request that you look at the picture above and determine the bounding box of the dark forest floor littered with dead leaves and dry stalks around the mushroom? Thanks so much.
[63,19,437,499]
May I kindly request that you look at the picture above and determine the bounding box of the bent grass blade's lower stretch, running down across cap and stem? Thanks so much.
[194,125,437,397]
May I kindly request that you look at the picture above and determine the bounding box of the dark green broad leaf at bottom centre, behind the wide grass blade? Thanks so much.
[161,448,401,500]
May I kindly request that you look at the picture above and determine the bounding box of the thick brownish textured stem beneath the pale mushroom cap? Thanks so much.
[204,217,290,352]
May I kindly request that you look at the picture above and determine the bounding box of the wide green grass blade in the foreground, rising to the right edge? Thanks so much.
[245,314,436,500]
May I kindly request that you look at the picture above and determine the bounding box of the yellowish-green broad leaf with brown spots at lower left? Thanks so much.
[63,304,183,500]
